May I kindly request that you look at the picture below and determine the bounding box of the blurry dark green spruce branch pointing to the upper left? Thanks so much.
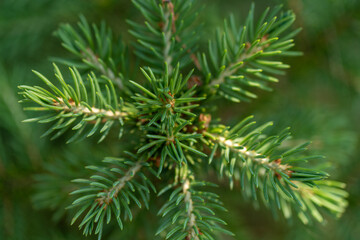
[55,16,128,90]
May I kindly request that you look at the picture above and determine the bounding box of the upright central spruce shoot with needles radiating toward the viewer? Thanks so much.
[132,64,206,170]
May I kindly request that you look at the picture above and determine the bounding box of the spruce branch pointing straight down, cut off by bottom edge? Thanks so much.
[156,173,233,240]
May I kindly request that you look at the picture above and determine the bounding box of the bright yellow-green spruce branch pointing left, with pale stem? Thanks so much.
[19,65,131,143]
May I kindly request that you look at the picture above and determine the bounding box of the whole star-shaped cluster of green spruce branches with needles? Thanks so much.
[20,0,347,240]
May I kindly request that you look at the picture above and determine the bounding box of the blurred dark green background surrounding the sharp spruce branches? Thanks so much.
[0,0,360,240]
